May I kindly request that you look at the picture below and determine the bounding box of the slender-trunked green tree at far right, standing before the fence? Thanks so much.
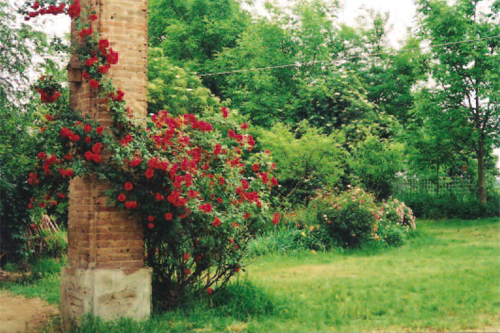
[417,0,500,204]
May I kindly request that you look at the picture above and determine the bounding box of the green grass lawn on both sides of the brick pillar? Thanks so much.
[1,219,500,332]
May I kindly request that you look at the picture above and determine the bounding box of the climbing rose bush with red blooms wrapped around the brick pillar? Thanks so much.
[25,1,280,305]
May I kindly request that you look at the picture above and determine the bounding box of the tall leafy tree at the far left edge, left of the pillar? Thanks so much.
[0,2,61,260]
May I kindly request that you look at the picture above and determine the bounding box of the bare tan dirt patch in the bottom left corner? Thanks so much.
[0,291,59,333]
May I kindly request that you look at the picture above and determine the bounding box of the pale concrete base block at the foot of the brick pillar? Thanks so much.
[60,267,152,324]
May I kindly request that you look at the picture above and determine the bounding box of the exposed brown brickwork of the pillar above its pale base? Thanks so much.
[68,0,148,272]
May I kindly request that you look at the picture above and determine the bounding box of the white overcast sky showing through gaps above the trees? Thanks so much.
[13,0,500,170]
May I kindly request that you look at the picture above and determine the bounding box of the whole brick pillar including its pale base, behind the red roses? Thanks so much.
[61,0,151,322]
